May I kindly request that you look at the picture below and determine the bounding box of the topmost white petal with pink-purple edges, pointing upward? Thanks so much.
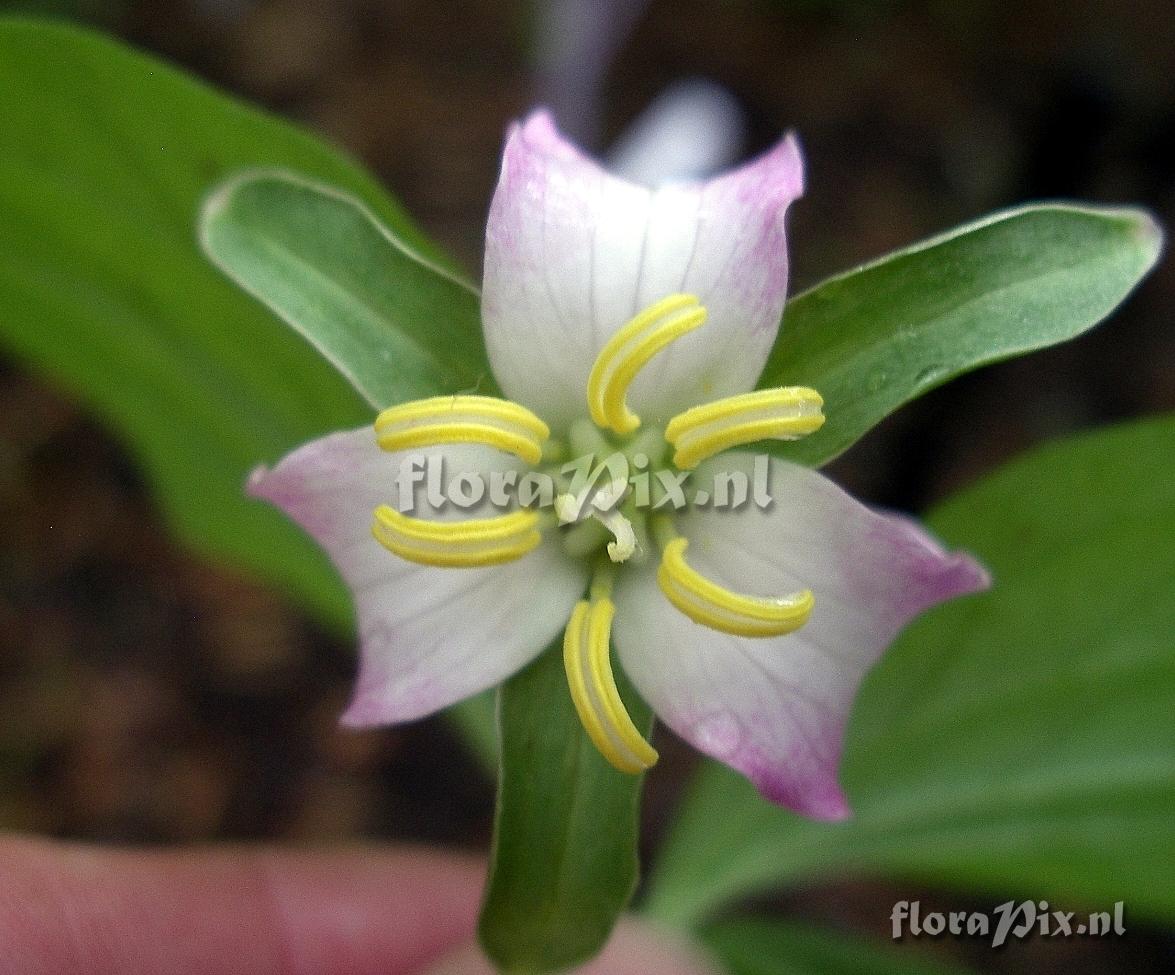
[482,113,803,430]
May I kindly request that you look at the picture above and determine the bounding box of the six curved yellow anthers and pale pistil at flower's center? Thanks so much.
[372,295,824,773]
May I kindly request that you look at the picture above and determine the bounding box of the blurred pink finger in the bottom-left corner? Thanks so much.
[0,838,484,975]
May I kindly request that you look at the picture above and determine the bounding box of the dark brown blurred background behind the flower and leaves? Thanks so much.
[0,0,1175,973]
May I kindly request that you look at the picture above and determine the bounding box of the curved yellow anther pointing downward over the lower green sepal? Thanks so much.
[563,599,657,775]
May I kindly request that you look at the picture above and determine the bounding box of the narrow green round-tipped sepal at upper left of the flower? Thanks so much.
[200,173,494,408]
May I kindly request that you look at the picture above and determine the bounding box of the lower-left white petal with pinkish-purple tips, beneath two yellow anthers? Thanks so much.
[249,426,586,725]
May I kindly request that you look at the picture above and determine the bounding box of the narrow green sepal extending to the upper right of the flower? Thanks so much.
[759,204,1162,466]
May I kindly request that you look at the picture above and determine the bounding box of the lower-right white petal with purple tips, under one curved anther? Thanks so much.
[613,453,988,819]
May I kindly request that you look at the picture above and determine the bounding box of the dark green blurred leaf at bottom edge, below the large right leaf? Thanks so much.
[699,919,967,975]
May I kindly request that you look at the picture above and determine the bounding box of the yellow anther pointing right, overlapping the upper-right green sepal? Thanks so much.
[665,386,824,471]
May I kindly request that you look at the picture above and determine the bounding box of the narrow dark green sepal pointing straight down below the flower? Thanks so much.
[478,646,652,973]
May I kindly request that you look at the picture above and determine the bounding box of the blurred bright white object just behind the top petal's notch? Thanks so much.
[607,79,746,186]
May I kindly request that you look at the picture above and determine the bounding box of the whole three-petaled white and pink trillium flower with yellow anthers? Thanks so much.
[250,113,987,819]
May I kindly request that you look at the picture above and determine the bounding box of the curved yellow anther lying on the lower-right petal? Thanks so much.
[657,538,814,637]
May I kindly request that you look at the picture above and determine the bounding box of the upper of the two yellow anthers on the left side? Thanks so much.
[375,396,551,464]
